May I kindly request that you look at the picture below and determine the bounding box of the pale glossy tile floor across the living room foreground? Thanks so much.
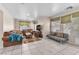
[0,38,79,55]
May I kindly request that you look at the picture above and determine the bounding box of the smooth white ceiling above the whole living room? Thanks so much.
[2,3,79,19]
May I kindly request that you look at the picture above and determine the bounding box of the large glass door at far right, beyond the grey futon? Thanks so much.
[71,17,79,45]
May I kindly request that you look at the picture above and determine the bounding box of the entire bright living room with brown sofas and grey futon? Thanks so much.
[0,3,79,55]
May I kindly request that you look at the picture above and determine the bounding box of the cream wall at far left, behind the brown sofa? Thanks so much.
[0,4,14,32]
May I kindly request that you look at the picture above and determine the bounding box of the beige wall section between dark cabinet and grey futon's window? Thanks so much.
[38,17,50,37]
